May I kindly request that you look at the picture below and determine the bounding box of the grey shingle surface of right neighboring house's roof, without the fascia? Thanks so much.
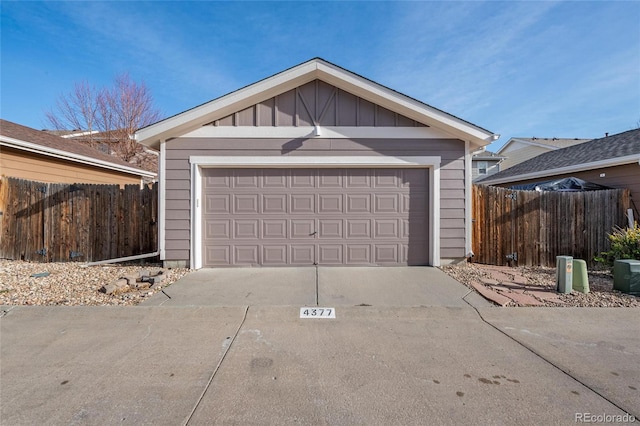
[482,129,640,183]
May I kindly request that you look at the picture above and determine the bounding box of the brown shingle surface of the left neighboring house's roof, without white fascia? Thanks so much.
[0,119,149,175]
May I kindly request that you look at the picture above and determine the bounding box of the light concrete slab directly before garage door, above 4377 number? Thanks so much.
[141,267,491,308]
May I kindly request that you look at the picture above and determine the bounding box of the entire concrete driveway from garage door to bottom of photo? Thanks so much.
[0,268,640,425]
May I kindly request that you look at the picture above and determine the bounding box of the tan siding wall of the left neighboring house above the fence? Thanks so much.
[0,146,141,188]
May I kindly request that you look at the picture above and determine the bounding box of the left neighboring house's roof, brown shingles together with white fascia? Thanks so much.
[0,119,156,178]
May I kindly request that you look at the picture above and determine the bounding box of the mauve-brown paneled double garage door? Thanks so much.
[202,168,429,267]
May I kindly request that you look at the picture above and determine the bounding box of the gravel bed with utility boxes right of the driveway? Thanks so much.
[440,263,640,308]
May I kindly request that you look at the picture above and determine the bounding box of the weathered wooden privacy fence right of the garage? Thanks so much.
[472,185,631,266]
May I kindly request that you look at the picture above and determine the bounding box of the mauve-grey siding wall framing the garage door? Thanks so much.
[165,138,465,261]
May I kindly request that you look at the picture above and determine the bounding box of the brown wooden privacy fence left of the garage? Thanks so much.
[0,177,158,262]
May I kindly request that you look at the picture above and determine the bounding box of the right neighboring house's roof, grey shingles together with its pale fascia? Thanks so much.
[479,129,640,184]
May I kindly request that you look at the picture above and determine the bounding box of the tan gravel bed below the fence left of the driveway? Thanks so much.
[0,260,189,306]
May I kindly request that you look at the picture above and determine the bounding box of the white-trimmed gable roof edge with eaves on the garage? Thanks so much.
[136,58,497,148]
